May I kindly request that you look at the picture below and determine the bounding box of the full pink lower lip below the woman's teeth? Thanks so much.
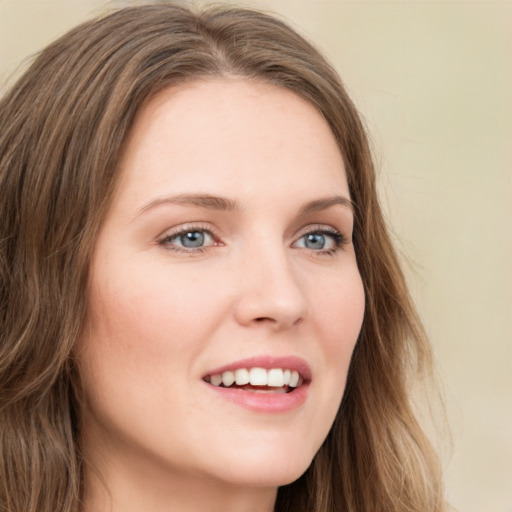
[205,383,309,413]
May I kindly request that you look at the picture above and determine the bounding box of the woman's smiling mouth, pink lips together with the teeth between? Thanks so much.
[203,356,311,412]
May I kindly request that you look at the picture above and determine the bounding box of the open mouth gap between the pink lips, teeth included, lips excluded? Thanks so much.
[203,366,305,394]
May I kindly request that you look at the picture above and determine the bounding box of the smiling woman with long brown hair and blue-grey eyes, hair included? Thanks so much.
[0,5,445,512]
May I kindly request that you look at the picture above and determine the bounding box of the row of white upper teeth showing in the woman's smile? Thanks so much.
[205,367,303,392]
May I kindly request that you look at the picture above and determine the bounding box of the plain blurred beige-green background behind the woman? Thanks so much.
[0,0,512,512]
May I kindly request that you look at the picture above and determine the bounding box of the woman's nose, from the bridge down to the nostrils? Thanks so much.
[235,247,308,331]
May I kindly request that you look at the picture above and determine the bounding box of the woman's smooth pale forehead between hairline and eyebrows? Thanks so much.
[115,78,348,209]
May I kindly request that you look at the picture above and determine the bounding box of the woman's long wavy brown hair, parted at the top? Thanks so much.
[0,3,445,512]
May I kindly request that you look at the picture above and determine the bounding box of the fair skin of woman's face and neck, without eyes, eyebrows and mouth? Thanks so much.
[77,78,364,512]
